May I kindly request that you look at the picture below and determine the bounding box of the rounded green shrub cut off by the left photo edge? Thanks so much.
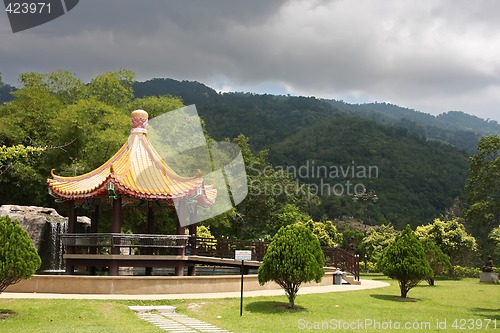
[0,216,42,293]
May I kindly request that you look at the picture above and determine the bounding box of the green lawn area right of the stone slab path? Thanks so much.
[176,276,500,333]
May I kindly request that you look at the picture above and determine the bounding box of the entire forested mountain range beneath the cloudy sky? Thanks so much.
[134,79,476,227]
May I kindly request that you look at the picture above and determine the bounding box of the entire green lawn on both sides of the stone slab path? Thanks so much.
[0,276,500,333]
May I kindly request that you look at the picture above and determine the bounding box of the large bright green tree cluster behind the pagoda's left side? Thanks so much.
[0,70,185,210]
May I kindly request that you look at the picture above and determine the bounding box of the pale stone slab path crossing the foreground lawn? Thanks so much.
[129,306,231,333]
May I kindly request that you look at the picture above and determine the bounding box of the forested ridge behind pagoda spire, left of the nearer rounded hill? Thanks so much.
[134,79,339,150]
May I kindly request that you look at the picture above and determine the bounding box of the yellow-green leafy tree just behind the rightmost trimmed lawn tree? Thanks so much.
[415,218,477,265]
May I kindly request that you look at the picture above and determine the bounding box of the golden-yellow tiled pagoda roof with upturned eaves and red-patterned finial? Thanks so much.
[47,110,217,205]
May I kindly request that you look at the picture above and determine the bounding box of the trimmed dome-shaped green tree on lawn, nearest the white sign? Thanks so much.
[259,223,325,308]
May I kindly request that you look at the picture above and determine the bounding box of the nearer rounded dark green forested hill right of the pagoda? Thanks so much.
[270,114,468,228]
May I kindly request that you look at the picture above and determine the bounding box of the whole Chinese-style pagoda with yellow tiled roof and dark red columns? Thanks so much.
[47,110,217,275]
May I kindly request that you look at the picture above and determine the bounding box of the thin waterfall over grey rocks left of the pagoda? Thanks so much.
[38,222,68,273]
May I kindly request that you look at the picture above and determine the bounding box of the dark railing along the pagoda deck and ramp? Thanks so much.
[61,233,359,280]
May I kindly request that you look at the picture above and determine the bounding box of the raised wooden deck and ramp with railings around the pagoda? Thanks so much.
[61,233,359,280]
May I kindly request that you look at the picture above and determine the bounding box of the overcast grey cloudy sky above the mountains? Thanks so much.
[0,0,500,121]
